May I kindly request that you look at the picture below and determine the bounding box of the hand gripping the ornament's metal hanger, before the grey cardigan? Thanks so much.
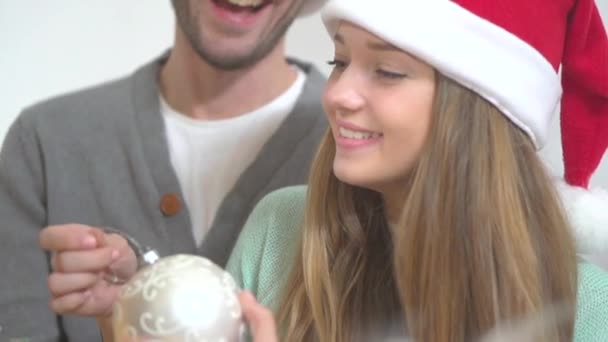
[39,224,137,316]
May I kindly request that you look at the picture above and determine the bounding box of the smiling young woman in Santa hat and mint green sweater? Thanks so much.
[41,0,608,342]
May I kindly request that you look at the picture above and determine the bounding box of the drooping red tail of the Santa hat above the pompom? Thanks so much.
[561,0,608,188]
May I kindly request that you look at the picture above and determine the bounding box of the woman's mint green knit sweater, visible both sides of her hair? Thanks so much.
[227,186,608,342]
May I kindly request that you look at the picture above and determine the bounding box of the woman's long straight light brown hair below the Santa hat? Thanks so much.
[278,74,577,342]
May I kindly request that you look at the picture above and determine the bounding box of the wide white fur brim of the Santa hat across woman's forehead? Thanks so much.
[322,0,562,148]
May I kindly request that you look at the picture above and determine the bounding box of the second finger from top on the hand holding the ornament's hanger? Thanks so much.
[54,247,120,273]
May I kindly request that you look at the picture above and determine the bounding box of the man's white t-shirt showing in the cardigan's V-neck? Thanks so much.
[160,69,306,246]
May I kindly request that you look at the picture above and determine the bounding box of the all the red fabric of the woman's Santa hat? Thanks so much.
[453,0,608,188]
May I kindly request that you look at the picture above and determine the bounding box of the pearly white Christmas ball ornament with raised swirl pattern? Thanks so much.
[114,255,245,342]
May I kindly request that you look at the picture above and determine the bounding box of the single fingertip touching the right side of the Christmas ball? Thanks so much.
[239,291,277,342]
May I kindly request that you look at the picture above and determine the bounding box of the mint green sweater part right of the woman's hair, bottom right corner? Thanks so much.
[574,263,608,342]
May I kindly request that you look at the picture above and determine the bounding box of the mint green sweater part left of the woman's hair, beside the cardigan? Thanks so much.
[226,186,306,310]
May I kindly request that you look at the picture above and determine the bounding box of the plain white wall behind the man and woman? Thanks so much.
[0,0,608,188]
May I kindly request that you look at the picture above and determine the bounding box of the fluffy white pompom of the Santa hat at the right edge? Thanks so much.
[556,180,608,254]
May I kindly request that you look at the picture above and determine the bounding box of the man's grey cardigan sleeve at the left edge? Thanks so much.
[0,115,59,342]
